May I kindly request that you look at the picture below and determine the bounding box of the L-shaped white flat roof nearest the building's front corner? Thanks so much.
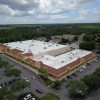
[34,49,91,69]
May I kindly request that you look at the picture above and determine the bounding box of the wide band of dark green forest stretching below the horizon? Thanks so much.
[0,24,100,43]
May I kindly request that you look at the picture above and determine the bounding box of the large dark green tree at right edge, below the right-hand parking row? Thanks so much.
[81,74,100,90]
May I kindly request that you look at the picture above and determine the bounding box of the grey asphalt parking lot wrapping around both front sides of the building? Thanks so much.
[0,54,100,100]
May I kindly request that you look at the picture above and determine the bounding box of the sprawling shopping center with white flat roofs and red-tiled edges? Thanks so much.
[0,40,96,80]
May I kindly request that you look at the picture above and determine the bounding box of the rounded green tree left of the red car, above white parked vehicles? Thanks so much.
[11,79,31,94]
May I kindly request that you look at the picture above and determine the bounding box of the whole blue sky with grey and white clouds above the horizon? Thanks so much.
[0,0,100,24]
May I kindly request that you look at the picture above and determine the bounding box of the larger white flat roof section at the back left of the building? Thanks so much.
[4,40,67,54]
